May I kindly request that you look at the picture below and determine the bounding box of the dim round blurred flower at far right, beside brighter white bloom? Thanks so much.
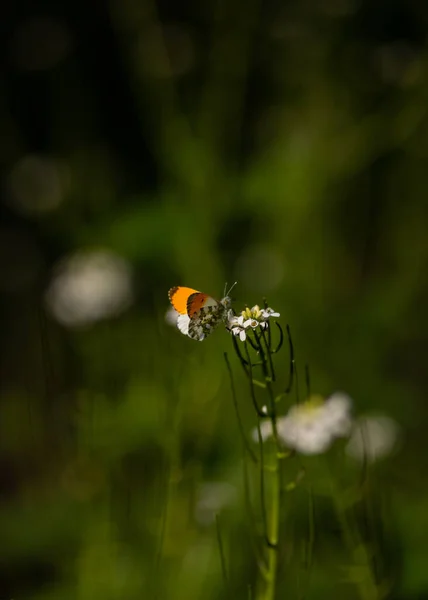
[346,414,400,462]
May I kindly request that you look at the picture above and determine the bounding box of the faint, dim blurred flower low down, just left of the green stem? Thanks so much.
[195,481,237,526]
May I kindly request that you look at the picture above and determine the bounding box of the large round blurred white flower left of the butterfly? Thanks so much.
[46,250,133,327]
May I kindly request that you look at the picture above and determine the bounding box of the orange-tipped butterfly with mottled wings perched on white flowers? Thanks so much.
[168,282,236,342]
